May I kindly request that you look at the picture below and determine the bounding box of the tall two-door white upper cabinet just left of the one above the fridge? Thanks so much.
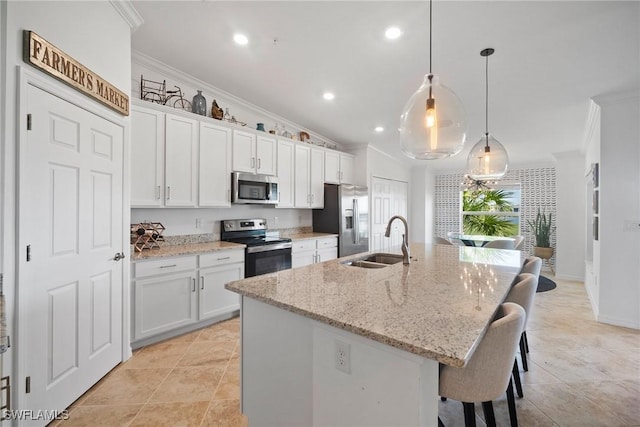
[294,144,324,208]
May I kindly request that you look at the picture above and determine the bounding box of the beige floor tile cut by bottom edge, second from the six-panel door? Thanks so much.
[129,401,209,427]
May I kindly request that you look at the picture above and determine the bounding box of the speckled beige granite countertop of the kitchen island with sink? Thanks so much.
[225,244,523,367]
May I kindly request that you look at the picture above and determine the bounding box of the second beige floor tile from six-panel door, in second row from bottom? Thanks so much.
[150,366,224,403]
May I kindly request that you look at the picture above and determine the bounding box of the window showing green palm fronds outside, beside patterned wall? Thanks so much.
[460,183,521,236]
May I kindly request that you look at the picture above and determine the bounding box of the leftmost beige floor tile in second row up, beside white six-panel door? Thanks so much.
[81,368,171,406]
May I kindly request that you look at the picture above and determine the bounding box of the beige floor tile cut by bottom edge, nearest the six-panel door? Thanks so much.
[57,404,142,427]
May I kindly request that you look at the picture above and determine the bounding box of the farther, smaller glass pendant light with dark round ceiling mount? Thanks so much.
[467,48,509,181]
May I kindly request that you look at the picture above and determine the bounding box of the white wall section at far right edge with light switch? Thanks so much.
[594,91,640,329]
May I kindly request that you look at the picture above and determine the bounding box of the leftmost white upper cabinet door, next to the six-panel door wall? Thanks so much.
[131,106,164,207]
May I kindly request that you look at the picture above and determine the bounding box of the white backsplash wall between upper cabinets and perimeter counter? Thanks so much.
[131,205,313,239]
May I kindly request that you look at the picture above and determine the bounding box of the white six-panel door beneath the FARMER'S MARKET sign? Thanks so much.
[20,85,124,425]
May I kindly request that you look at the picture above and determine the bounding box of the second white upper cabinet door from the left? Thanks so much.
[165,114,198,207]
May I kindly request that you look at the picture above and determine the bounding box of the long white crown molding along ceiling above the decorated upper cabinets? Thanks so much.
[131,50,345,151]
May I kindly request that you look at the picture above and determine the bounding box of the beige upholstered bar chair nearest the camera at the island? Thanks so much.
[438,302,526,427]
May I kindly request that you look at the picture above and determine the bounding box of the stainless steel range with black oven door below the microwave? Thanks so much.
[220,218,293,277]
